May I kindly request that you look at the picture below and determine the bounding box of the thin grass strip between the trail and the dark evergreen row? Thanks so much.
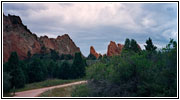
[11,79,83,92]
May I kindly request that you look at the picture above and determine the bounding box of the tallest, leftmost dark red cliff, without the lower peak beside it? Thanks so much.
[3,15,41,62]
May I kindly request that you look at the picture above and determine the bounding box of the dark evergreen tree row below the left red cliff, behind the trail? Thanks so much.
[3,50,87,93]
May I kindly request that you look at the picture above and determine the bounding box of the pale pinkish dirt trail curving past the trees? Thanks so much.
[14,81,87,97]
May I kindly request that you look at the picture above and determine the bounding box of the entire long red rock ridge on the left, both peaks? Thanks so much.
[3,14,80,62]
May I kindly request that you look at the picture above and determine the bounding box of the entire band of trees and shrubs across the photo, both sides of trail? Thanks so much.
[3,38,177,97]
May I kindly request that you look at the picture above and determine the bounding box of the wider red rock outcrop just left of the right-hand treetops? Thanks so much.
[107,41,123,56]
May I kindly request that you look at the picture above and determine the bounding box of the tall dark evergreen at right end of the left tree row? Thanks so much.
[71,52,85,78]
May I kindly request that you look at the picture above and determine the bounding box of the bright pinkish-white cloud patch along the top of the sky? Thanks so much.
[4,3,143,29]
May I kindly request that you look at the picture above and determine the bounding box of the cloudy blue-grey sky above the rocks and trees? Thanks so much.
[3,2,177,56]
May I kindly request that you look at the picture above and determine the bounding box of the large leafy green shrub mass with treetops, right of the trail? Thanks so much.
[72,38,177,97]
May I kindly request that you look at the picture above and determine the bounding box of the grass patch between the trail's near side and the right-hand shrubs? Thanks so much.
[39,86,75,97]
